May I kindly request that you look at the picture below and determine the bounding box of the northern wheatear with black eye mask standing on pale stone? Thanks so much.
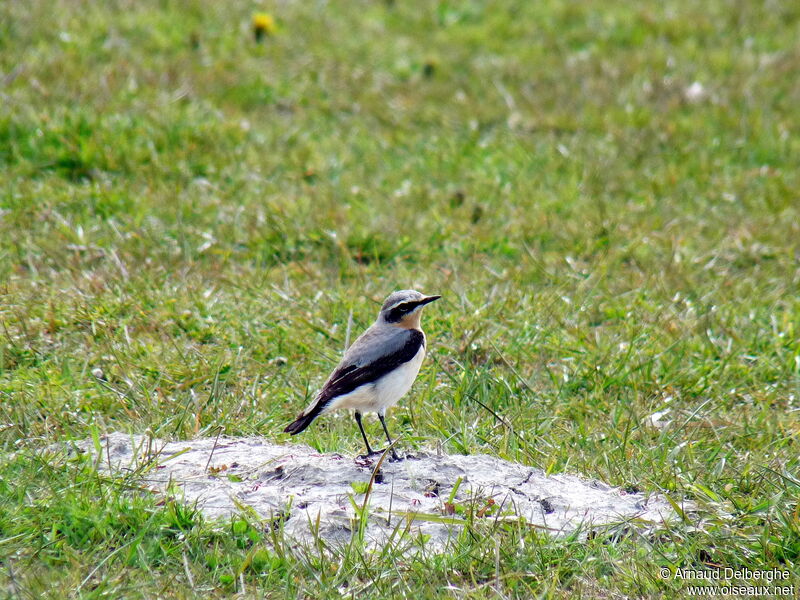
[284,290,441,460]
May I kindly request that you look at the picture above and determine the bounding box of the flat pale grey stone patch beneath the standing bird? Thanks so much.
[72,433,692,551]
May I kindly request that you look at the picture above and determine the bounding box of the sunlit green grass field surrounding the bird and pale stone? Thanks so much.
[0,0,800,599]
